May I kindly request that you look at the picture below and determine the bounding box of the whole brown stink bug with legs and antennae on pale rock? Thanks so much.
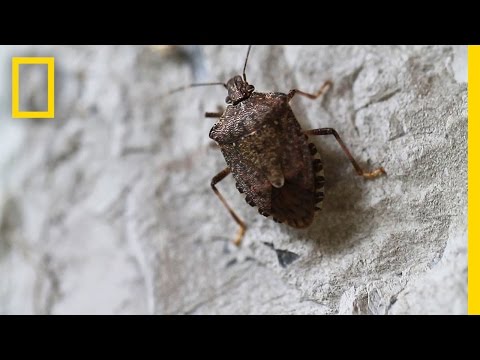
[167,46,385,245]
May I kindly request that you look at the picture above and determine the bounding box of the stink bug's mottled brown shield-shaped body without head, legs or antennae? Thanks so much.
[210,93,325,228]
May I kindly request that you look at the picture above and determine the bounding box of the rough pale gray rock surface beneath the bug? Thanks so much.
[0,46,467,314]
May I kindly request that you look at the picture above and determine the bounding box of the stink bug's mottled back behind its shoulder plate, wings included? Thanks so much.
[221,105,323,228]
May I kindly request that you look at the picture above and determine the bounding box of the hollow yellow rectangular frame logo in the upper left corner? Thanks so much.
[12,57,55,119]
